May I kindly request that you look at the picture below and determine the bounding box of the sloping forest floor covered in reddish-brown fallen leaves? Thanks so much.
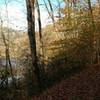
[32,65,100,100]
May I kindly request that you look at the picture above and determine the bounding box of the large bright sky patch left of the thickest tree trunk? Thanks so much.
[0,0,27,29]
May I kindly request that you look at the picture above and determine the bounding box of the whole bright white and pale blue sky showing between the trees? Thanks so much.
[0,0,95,30]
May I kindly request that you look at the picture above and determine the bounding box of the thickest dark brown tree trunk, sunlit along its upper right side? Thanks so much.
[26,0,44,90]
